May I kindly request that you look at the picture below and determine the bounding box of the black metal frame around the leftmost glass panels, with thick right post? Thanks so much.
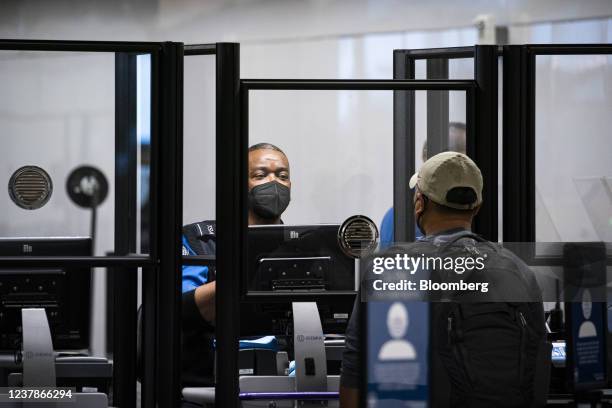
[0,40,183,406]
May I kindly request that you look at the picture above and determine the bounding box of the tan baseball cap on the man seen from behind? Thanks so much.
[410,152,482,210]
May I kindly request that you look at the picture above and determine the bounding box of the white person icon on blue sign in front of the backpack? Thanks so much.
[378,302,416,361]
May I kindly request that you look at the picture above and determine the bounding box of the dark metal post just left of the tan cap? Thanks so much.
[393,51,415,242]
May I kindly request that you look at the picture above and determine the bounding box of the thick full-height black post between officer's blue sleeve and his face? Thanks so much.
[215,43,241,408]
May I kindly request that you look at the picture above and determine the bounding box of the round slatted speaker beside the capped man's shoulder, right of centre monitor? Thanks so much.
[338,215,378,258]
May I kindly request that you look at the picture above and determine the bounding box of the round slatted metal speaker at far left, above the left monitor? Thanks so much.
[8,166,53,210]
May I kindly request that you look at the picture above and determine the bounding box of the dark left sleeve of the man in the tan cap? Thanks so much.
[340,294,361,388]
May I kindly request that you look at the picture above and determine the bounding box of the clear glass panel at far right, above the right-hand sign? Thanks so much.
[535,55,612,242]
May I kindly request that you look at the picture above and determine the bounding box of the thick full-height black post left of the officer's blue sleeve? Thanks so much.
[154,43,183,407]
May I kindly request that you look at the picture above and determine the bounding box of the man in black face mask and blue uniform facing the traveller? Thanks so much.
[182,143,291,386]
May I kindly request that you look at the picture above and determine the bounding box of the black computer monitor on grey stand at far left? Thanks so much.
[0,237,92,352]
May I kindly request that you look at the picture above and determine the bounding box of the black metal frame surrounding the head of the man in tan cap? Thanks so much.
[393,45,501,242]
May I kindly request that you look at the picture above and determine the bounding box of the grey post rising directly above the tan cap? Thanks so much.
[426,58,449,157]
